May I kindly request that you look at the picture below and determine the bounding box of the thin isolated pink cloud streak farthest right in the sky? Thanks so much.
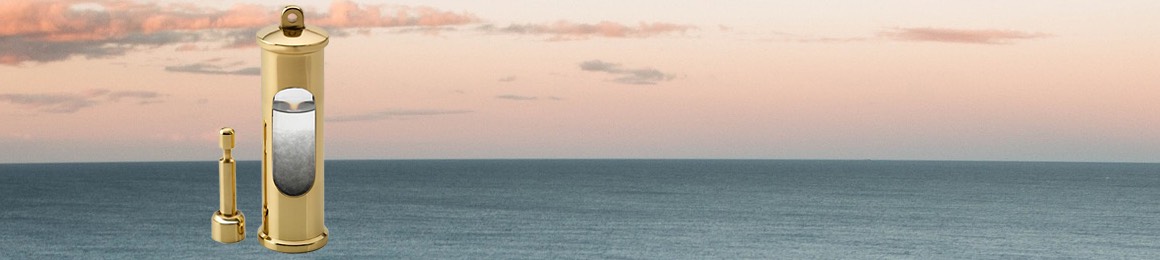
[878,28,1051,44]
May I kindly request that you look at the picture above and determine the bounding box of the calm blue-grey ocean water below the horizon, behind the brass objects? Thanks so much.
[0,160,1160,259]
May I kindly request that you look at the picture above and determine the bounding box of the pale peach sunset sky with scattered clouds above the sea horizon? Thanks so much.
[0,0,1160,163]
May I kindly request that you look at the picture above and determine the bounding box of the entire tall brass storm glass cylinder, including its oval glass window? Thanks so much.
[258,6,329,253]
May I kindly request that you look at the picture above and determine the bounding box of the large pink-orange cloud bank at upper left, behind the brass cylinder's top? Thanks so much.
[0,0,479,65]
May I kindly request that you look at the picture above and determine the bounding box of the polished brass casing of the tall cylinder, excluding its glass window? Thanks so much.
[258,6,329,253]
